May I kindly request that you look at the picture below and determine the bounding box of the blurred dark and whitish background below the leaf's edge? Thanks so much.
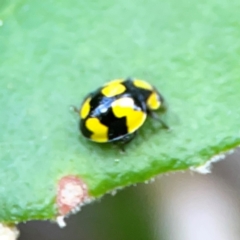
[18,149,240,240]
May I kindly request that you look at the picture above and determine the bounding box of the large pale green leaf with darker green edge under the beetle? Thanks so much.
[0,0,240,222]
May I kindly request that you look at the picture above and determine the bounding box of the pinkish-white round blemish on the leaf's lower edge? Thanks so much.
[57,176,89,216]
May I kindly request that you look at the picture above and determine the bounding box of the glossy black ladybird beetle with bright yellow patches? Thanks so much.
[77,78,168,147]
